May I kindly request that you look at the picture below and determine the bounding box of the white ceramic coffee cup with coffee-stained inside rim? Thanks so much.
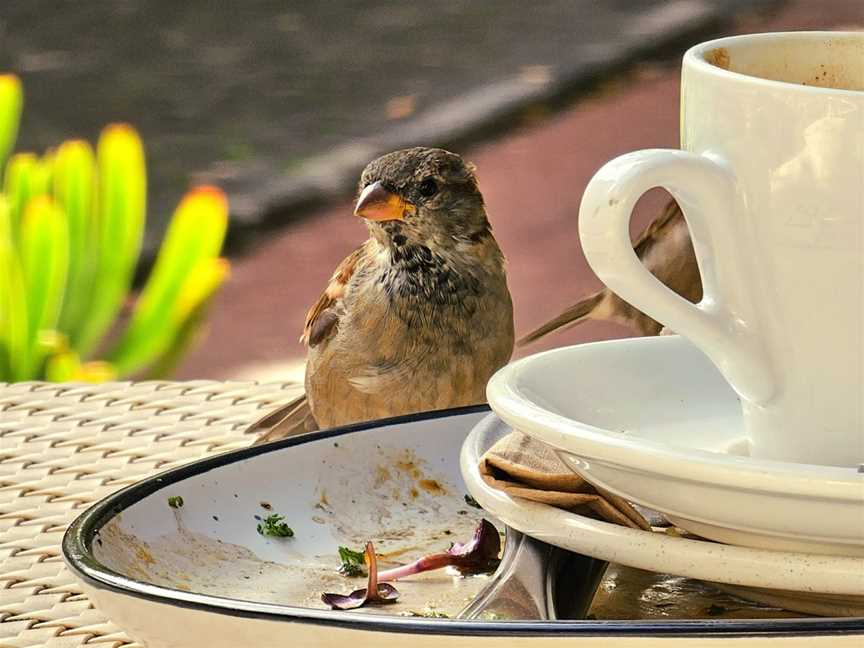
[579,32,864,466]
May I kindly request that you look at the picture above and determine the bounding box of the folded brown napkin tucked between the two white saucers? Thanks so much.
[480,432,651,531]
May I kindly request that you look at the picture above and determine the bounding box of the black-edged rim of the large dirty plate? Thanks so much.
[62,405,864,638]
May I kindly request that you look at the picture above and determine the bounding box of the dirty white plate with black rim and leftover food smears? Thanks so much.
[63,408,864,648]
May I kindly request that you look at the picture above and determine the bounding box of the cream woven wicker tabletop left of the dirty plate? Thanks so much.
[0,381,302,648]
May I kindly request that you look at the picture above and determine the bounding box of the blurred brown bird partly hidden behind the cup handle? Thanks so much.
[518,200,702,346]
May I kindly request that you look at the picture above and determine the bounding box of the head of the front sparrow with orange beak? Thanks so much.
[354,147,489,246]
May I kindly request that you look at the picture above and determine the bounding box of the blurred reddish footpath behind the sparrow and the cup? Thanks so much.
[178,0,864,379]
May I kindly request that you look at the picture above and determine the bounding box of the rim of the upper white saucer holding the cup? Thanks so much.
[486,335,864,504]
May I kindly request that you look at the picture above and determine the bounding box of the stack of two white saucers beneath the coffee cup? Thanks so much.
[462,336,864,614]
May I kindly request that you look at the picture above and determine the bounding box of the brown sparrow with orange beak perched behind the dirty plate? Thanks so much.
[253,148,513,442]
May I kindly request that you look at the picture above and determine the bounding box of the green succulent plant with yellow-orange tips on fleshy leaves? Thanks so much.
[0,74,228,382]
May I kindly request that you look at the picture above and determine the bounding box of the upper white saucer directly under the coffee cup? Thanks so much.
[487,336,864,556]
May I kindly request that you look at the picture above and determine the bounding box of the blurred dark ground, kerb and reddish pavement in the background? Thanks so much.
[0,0,864,378]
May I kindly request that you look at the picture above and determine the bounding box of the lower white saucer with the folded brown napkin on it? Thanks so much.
[460,416,864,615]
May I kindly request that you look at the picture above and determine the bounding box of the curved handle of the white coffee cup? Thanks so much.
[579,149,775,403]
